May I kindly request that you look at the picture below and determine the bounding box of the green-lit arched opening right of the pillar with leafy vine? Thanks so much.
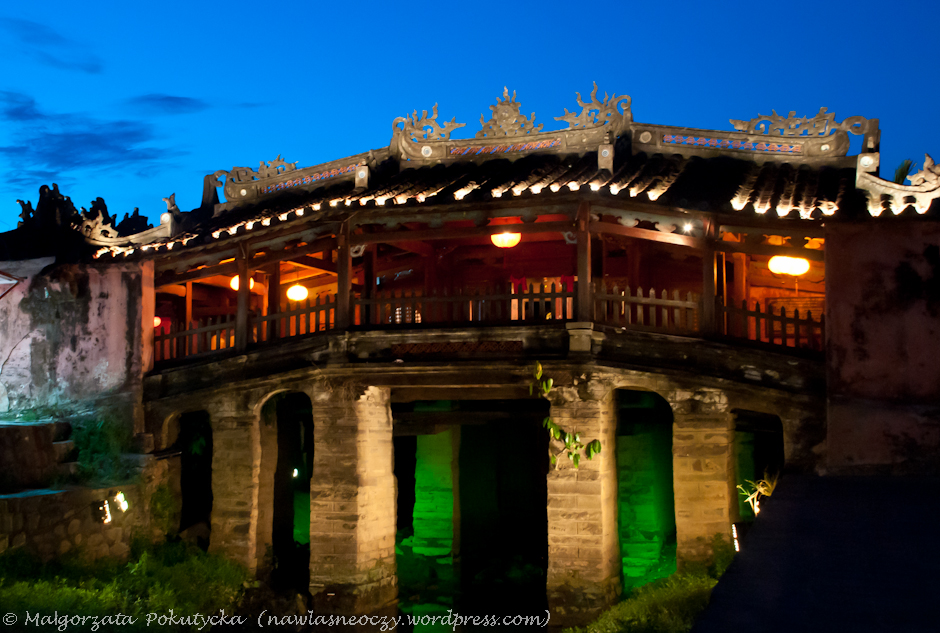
[617,389,676,590]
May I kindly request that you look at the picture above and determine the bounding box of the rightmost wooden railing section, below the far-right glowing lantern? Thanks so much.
[715,299,826,351]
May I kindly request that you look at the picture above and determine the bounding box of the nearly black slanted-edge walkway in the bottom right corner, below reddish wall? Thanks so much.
[692,475,940,633]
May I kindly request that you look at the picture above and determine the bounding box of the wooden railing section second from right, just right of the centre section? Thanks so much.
[594,284,700,333]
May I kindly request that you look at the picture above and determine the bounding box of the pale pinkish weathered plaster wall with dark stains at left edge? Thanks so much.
[0,258,152,430]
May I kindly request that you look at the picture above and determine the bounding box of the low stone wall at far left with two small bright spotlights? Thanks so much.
[0,485,147,561]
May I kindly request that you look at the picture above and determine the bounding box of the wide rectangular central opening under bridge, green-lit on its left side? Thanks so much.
[392,399,550,628]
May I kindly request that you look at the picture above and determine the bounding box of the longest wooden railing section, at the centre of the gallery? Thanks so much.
[353,284,575,327]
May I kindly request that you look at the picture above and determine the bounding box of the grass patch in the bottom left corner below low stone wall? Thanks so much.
[0,541,249,631]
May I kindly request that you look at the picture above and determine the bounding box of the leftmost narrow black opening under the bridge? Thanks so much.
[176,411,212,550]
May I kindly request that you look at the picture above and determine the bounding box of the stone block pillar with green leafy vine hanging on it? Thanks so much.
[547,388,621,626]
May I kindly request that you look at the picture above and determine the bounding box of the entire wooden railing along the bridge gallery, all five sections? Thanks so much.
[154,283,825,363]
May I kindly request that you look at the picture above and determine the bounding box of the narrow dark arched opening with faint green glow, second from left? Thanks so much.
[271,393,314,592]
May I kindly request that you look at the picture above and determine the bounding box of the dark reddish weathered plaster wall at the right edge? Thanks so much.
[826,219,940,472]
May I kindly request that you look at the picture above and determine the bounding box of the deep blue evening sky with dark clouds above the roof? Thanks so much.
[0,0,940,231]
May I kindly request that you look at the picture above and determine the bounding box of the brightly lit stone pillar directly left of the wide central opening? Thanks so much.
[310,384,398,613]
